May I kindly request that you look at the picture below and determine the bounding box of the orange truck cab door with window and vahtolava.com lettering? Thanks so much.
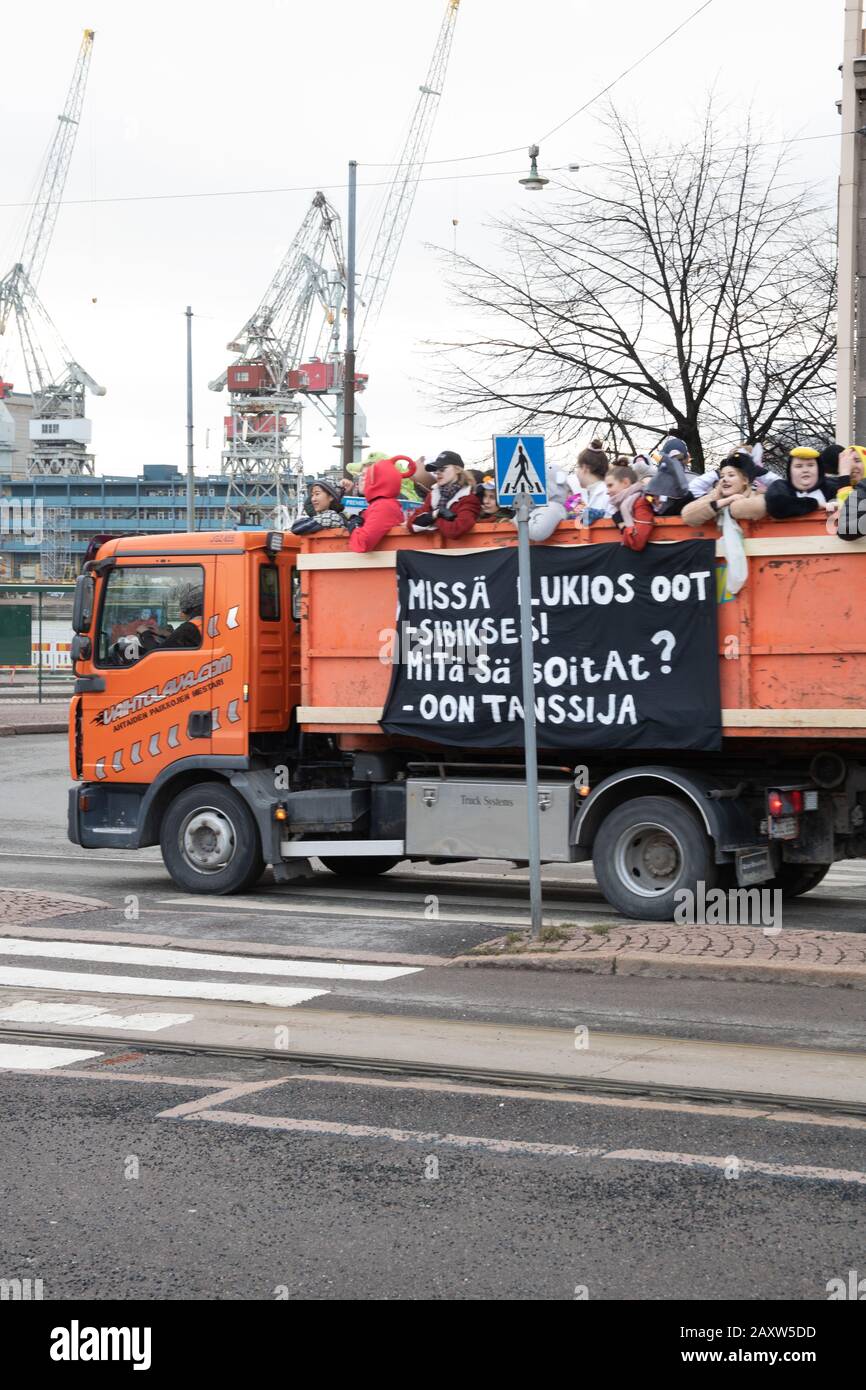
[79,556,215,783]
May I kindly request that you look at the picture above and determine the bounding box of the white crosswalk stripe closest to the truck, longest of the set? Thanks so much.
[0,937,423,981]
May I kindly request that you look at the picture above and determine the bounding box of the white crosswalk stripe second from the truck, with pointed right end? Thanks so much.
[0,966,331,1009]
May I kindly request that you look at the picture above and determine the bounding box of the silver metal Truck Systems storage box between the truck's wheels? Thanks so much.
[406,777,574,863]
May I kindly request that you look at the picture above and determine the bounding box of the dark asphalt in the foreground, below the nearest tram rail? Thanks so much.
[6,1055,866,1301]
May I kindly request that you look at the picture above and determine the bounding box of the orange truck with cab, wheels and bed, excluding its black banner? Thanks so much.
[70,517,866,920]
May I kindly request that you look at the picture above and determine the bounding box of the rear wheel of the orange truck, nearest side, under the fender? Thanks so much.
[592,796,717,922]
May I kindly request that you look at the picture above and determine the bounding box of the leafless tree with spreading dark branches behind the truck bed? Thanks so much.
[436,107,835,468]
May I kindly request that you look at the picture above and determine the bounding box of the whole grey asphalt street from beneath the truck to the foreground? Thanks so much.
[0,735,866,1302]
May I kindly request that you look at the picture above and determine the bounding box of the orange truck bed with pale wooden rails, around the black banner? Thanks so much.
[293,517,866,748]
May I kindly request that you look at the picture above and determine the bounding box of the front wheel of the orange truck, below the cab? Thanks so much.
[160,783,264,894]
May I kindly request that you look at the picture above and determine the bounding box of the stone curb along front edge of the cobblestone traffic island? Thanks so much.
[452,951,866,990]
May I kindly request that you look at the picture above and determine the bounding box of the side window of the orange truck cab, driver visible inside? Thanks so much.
[96,564,204,664]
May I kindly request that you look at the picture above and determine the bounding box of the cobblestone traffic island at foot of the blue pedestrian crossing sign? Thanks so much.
[464,923,866,990]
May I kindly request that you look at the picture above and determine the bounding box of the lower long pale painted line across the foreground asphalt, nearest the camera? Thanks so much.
[176,1095,866,1187]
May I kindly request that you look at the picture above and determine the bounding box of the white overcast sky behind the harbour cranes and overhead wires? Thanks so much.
[0,0,844,483]
